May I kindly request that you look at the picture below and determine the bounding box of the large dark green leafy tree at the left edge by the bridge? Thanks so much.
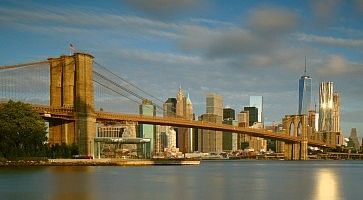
[0,100,47,159]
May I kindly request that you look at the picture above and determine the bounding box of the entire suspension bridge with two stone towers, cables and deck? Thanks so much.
[0,53,336,160]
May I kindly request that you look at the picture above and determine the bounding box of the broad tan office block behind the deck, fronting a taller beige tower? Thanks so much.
[198,114,223,153]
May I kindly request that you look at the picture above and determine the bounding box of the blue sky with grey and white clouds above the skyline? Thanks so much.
[0,0,363,136]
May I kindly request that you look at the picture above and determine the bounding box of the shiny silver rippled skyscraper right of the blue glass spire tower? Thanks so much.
[319,82,334,132]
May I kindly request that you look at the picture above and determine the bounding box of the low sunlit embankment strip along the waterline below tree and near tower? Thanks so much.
[0,159,200,167]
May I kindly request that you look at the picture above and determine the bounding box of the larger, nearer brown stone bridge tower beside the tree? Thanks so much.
[48,53,96,155]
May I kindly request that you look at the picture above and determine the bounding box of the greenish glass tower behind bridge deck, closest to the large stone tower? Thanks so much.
[138,100,156,158]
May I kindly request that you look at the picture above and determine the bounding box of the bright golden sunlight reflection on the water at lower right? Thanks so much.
[314,168,343,200]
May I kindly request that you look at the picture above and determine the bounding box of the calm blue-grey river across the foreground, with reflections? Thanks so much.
[0,160,363,200]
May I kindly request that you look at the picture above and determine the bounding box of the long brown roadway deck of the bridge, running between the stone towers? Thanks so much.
[28,104,334,147]
